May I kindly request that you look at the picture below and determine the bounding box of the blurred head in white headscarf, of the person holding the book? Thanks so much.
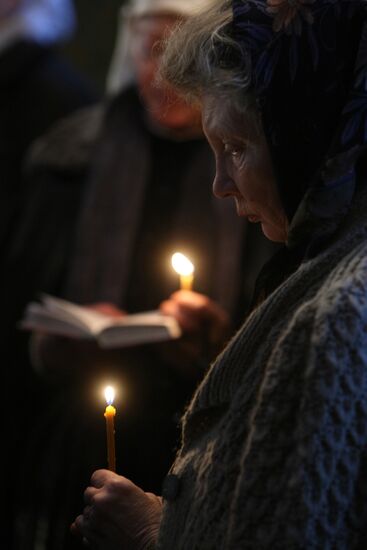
[107,0,217,131]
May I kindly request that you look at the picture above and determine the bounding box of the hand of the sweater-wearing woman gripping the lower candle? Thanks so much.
[71,470,162,550]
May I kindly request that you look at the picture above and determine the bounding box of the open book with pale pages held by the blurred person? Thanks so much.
[20,295,181,348]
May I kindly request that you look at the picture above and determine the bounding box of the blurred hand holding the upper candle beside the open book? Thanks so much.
[160,290,230,361]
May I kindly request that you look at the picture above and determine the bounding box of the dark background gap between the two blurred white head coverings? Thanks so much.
[61,0,124,92]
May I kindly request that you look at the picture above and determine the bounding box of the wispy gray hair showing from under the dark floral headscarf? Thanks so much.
[160,0,256,117]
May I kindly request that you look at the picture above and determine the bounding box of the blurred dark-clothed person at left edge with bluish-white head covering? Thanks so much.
[0,0,98,548]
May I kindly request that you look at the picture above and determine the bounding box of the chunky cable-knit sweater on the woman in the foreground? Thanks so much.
[157,188,367,550]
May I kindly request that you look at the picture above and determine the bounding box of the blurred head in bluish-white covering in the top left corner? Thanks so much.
[0,0,75,53]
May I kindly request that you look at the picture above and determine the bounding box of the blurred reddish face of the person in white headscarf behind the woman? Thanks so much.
[131,15,201,130]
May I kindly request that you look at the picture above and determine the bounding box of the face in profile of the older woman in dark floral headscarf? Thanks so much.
[203,98,288,242]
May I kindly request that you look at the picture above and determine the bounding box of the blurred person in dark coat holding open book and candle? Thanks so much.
[2,0,274,549]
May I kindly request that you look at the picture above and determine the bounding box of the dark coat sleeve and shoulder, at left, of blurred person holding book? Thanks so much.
[0,105,103,328]
